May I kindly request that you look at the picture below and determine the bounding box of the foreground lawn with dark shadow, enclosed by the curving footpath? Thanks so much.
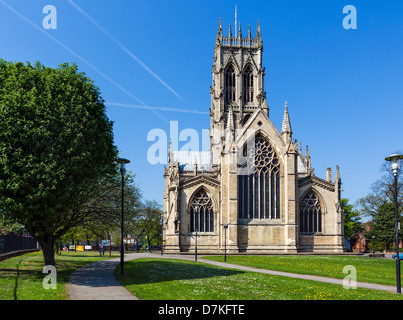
[116,258,403,300]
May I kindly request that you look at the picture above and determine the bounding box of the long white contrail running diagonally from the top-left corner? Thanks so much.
[0,0,169,122]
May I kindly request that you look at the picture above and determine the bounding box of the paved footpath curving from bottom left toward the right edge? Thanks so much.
[67,253,396,300]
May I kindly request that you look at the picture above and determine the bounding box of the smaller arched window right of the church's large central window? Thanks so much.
[299,190,322,233]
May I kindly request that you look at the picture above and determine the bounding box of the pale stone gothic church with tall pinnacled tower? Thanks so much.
[163,20,344,254]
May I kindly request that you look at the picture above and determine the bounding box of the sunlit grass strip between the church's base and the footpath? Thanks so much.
[203,255,396,286]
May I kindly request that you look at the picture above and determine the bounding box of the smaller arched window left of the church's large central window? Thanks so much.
[190,189,214,232]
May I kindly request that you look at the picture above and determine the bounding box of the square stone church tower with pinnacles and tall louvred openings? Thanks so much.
[210,19,269,160]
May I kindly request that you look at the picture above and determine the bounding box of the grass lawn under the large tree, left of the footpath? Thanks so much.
[0,251,117,300]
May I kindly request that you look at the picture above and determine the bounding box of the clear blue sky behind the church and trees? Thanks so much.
[0,0,403,208]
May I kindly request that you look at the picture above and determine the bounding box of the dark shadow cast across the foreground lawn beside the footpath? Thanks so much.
[115,259,244,285]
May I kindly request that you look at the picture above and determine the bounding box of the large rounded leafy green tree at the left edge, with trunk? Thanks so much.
[0,60,117,265]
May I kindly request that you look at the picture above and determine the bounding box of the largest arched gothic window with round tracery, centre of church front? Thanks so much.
[238,136,280,219]
